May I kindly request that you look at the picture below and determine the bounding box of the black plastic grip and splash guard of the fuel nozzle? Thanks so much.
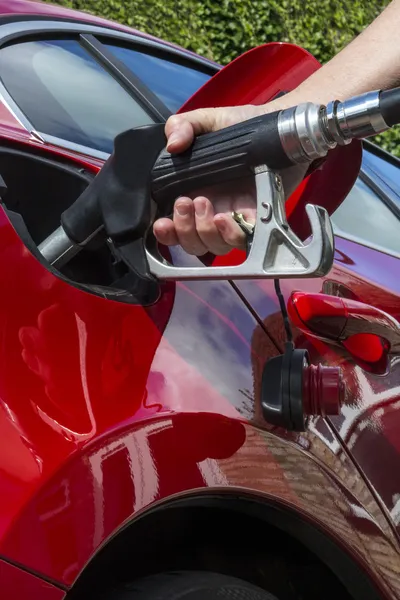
[61,112,292,253]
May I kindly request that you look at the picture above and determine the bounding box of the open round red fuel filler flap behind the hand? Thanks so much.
[183,43,362,243]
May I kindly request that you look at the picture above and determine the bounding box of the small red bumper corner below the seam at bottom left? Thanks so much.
[0,560,65,600]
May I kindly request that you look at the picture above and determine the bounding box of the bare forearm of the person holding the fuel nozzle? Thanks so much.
[286,0,400,103]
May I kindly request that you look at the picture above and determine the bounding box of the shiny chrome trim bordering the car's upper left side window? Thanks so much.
[0,18,221,151]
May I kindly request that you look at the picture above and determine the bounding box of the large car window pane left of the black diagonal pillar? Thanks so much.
[0,40,152,153]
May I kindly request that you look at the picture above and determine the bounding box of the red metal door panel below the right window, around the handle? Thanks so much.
[220,175,400,534]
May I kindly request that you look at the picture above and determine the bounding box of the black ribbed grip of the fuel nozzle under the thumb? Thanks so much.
[151,111,293,206]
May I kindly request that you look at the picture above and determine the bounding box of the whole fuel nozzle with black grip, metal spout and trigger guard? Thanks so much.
[39,88,400,281]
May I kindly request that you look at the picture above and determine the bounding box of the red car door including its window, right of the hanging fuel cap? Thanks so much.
[235,144,400,533]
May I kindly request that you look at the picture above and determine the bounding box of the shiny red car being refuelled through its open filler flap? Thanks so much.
[0,0,400,600]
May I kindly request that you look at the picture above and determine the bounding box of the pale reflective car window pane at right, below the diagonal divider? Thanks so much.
[331,179,400,254]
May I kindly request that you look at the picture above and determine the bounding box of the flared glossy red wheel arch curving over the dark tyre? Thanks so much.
[0,413,400,598]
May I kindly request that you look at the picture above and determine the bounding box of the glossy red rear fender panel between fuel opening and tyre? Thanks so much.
[0,205,397,598]
